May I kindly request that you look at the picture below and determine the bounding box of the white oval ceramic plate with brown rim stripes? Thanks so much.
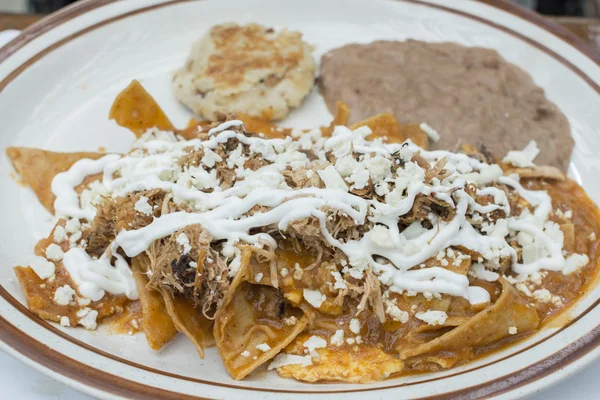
[0,0,600,400]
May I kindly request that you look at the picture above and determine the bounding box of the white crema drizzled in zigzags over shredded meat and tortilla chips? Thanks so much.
[52,121,584,304]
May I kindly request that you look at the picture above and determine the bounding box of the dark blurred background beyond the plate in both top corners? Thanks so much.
[0,0,600,18]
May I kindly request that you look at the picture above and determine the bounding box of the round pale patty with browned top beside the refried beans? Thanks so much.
[173,24,316,120]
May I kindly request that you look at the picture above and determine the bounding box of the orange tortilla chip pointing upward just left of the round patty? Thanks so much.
[108,80,175,137]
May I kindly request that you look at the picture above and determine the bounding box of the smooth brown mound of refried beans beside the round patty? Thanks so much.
[320,40,573,170]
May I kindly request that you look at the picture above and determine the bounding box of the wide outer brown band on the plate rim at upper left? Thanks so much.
[0,0,117,63]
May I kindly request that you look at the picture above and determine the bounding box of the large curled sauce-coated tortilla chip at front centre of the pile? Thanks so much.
[214,250,308,380]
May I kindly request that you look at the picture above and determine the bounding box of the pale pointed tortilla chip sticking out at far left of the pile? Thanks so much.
[6,147,106,214]
